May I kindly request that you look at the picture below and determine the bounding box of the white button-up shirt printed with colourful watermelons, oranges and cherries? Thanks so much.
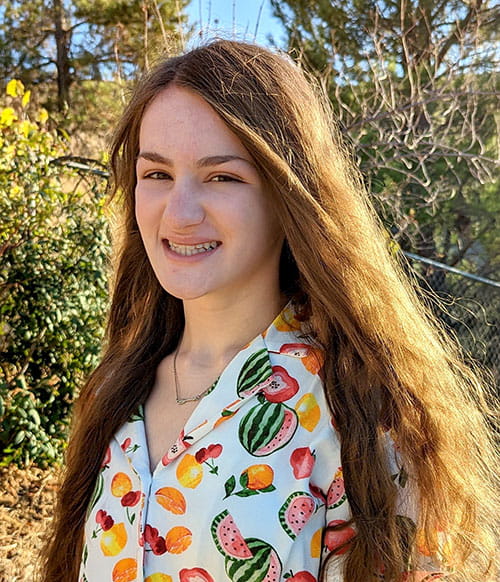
[79,305,446,582]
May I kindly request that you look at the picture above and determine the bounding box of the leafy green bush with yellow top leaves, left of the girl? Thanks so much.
[0,81,110,466]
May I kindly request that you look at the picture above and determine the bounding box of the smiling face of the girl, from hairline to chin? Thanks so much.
[135,85,283,302]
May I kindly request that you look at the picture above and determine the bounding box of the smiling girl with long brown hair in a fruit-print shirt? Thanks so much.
[44,41,493,582]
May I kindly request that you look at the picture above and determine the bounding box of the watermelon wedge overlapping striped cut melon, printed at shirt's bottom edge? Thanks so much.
[211,509,282,582]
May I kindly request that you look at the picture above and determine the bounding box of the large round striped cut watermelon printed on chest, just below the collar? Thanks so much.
[238,394,298,457]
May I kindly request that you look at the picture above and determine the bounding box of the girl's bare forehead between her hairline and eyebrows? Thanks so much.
[139,85,248,155]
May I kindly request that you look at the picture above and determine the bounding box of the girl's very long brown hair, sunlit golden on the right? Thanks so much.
[43,41,495,582]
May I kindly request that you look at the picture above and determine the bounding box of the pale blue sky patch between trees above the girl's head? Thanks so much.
[186,0,284,48]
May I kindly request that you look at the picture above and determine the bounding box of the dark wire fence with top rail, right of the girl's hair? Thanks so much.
[405,253,500,386]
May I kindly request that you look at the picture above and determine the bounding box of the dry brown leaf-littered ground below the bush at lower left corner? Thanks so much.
[0,467,56,582]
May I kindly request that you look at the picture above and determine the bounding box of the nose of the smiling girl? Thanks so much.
[163,178,205,231]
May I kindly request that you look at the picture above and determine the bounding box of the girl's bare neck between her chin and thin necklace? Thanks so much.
[179,291,286,367]
